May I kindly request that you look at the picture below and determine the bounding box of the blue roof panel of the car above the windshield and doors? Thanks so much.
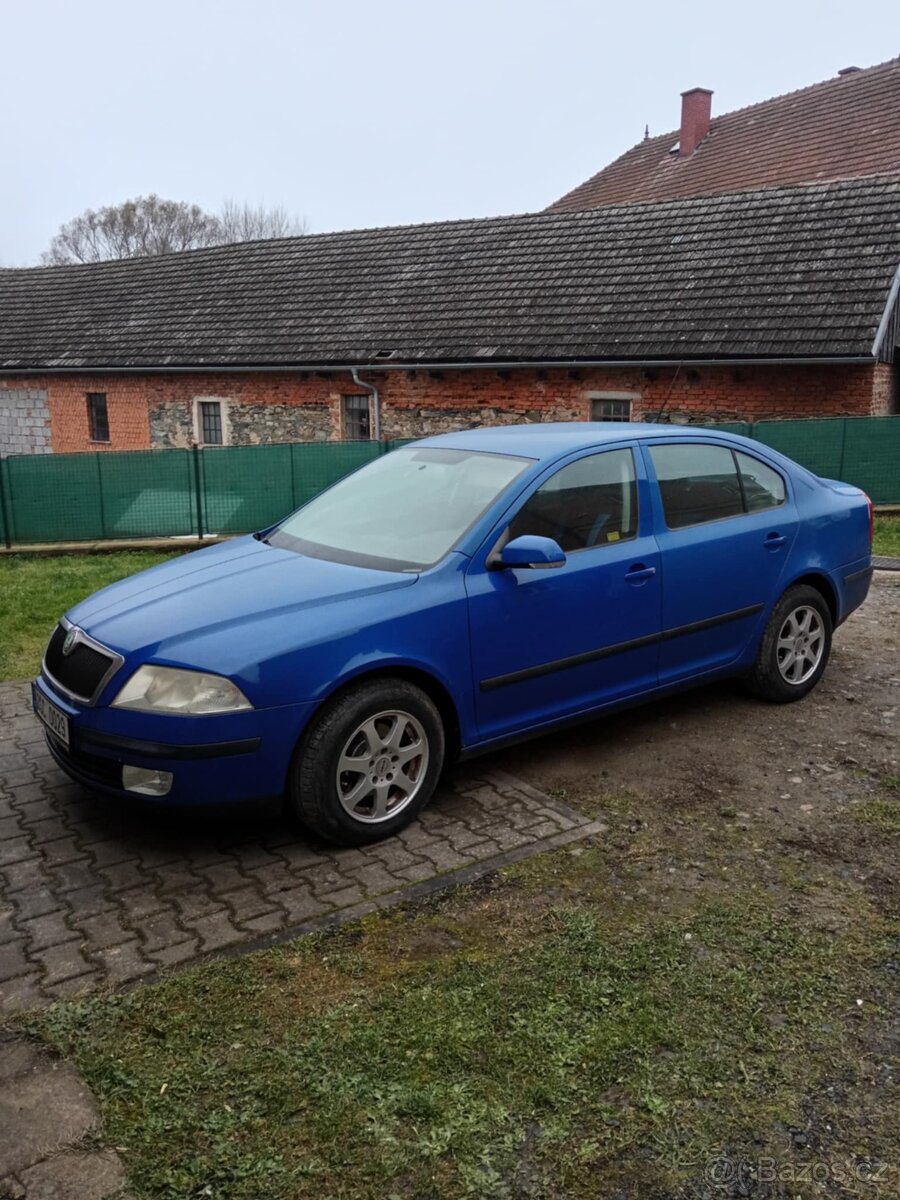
[415,421,752,461]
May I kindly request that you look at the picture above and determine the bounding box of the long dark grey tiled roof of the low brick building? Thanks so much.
[0,179,900,371]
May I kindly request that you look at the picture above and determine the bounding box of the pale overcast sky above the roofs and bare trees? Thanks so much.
[0,0,900,266]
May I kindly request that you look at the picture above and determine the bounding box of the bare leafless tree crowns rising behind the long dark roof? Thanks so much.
[41,196,306,266]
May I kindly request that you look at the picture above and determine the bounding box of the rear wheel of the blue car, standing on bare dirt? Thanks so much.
[746,583,832,704]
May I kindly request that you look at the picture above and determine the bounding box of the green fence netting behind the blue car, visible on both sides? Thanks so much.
[0,427,900,546]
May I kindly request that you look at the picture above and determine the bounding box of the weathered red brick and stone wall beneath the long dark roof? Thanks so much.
[0,364,900,451]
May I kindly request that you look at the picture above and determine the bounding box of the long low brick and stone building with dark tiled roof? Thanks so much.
[0,176,900,452]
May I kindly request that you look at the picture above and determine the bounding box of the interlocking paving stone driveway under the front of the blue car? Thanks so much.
[0,683,601,1013]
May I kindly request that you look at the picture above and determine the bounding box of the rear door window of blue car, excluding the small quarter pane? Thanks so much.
[650,443,744,529]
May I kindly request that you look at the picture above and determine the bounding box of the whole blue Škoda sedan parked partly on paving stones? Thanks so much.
[34,424,871,845]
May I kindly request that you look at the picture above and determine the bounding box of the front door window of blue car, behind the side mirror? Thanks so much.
[509,450,637,554]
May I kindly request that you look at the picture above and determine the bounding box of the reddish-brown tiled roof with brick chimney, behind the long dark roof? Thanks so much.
[548,58,900,212]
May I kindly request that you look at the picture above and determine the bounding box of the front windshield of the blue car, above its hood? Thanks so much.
[266,446,530,571]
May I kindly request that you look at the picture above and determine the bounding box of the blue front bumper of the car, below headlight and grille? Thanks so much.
[35,678,317,805]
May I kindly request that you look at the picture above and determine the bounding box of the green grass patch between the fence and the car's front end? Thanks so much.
[0,551,181,679]
